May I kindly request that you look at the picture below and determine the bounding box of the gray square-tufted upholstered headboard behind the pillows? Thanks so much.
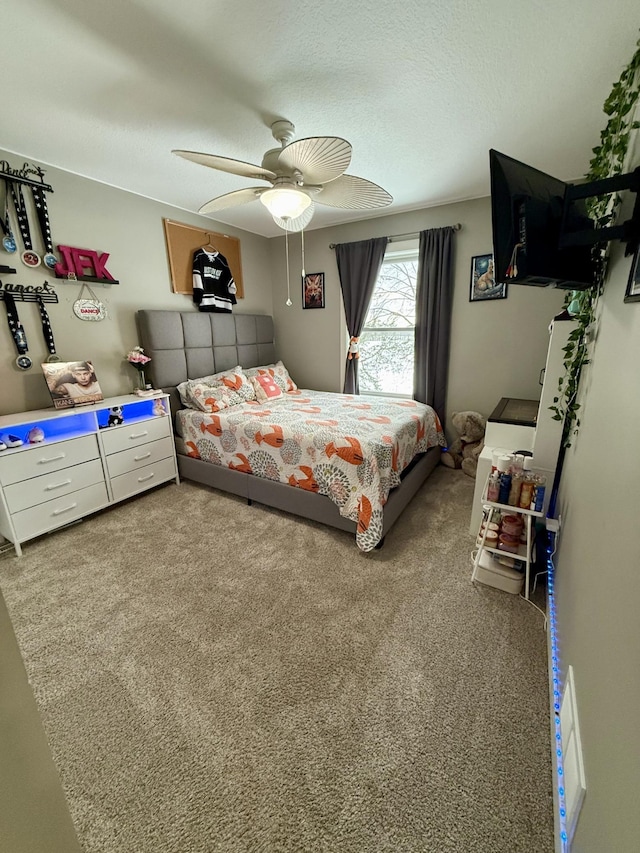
[136,310,276,413]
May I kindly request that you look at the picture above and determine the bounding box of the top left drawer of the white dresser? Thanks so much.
[0,432,100,486]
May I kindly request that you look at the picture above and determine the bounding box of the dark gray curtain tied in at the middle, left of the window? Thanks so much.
[336,237,388,394]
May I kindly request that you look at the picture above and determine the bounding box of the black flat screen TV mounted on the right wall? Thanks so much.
[489,149,594,290]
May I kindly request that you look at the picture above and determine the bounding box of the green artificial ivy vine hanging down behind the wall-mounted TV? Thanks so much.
[550,35,640,447]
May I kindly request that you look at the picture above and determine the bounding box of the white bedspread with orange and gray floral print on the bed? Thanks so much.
[176,390,445,551]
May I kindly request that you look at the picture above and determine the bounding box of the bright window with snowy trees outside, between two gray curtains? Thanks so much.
[358,248,418,397]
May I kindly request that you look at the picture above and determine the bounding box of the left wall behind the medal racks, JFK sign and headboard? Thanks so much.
[0,151,272,414]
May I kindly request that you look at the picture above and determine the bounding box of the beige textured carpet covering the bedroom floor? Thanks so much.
[0,467,553,853]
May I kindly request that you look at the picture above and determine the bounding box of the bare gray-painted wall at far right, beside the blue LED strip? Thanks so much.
[555,178,640,853]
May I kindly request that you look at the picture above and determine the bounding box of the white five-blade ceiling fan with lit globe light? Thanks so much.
[173,119,393,231]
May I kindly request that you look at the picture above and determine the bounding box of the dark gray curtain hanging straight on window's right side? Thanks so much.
[413,227,454,427]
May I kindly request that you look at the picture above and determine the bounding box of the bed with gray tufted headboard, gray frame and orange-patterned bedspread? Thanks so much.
[137,310,444,551]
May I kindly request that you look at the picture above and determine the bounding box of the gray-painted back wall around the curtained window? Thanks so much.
[271,198,564,432]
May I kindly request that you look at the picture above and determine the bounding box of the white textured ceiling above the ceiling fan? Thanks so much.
[0,0,639,236]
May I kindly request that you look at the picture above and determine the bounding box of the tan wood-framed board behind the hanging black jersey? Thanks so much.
[162,219,244,299]
